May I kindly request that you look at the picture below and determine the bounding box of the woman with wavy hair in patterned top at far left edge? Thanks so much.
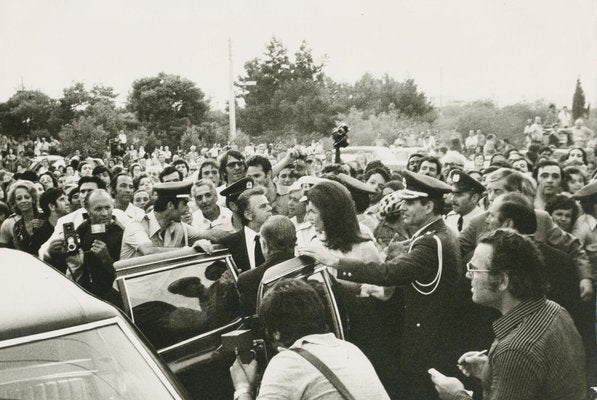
[0,181,43,254]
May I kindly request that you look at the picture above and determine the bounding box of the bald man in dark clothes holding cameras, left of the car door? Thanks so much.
[48,189,124,301]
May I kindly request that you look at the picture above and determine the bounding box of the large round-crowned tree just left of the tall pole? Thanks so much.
[127,72,209,147]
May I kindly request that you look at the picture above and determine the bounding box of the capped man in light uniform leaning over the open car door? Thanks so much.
[120,182,219,260]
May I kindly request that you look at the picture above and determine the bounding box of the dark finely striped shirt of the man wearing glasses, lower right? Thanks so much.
[456,299,587,400]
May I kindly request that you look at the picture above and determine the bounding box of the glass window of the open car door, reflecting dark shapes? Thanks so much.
[124,260,240,350]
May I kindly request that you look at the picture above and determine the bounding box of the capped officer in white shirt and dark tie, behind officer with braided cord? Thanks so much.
[446,169,485,233]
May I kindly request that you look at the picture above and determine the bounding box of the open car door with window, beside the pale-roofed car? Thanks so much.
[115,249,242,399]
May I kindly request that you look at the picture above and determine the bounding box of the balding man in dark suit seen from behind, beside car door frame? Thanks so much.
[238,215,296,317]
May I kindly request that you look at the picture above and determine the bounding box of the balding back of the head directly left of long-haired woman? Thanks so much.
[259,215,296,258]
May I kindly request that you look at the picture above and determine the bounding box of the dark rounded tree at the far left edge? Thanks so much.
[0,90,60,137]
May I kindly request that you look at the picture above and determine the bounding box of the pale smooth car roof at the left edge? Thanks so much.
[0,249,121,341]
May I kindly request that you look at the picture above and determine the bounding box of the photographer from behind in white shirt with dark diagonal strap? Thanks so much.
[230,279,389,400]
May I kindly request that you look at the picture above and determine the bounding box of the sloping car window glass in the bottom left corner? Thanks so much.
[0,324,175,400]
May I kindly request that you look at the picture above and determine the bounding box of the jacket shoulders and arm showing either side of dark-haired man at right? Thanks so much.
[458,210,591,280]
